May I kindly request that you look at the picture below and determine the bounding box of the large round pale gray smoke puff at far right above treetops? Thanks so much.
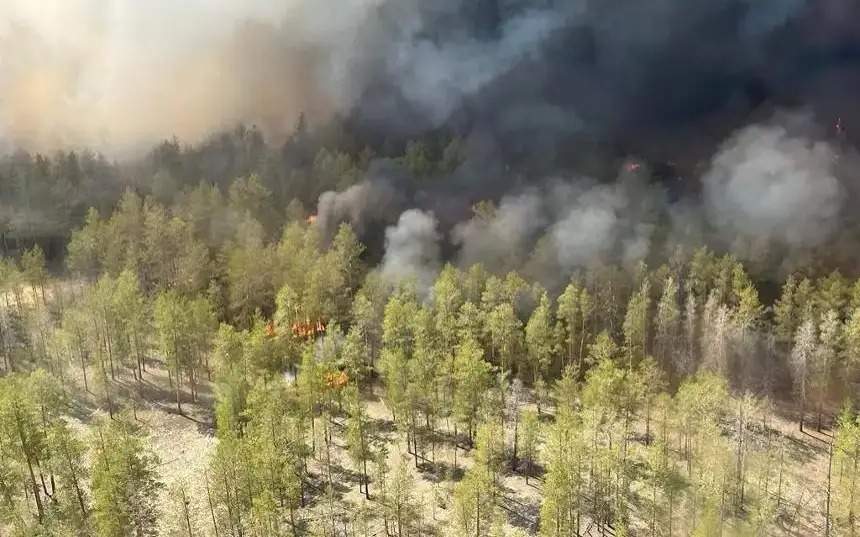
[702,119,847,255]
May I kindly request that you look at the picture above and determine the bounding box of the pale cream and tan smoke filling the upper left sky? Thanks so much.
[0,0,371,155]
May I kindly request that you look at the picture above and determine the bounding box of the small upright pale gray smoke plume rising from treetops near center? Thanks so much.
[382,209,441,294]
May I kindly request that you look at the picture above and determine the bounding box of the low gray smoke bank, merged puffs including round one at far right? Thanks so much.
[372,114,858,286]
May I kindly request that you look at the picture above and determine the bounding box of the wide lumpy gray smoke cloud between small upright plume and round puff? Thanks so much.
[452,170,667,284]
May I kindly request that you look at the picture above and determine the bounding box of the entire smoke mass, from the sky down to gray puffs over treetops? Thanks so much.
[5,0,860,280]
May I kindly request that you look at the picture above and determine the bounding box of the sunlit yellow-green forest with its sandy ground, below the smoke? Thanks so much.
[0,135,860,537]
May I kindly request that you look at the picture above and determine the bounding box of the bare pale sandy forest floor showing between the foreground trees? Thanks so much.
[62,360,831,537]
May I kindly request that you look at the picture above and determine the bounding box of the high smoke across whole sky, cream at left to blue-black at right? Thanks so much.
[5,0,860,156]
